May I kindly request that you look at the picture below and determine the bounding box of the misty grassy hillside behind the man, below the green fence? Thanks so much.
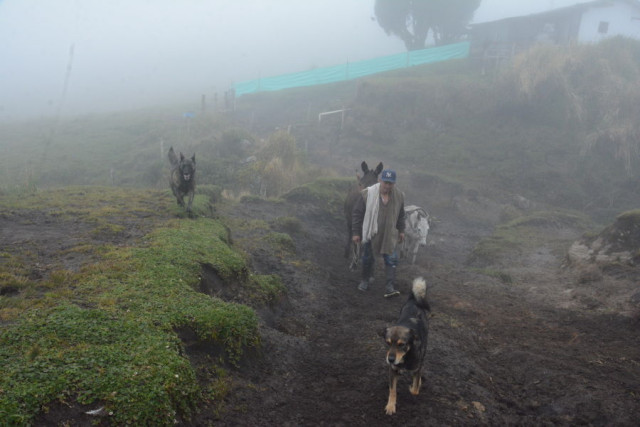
[0,39,640,219]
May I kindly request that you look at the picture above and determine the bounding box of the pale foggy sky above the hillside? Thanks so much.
[0,0,592,120]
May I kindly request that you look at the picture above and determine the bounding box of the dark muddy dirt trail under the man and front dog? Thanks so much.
[202,179,640,426]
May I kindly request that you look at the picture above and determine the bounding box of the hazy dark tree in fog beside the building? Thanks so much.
[375,0,480,50]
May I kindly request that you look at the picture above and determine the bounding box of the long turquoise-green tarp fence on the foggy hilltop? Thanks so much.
[233,42,469,96]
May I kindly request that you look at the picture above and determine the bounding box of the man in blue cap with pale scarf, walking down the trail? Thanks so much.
[352,169,404,298]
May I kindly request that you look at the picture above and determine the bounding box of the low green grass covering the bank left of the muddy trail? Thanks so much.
[0,188,285,425]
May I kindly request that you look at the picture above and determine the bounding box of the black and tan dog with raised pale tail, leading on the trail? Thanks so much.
[381,277,431,415]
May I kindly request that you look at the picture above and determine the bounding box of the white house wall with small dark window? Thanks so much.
[578,3,640,43]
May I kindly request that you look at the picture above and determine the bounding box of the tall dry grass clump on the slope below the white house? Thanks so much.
[500,37,640,175]
